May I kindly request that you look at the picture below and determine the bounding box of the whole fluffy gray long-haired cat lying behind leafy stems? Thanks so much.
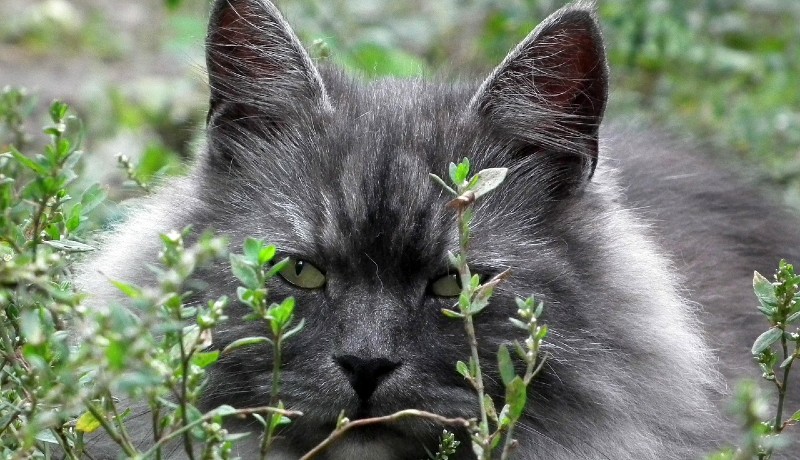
[80,0,800,460]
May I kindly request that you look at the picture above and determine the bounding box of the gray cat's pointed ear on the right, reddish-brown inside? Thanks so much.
[470,2,608,190]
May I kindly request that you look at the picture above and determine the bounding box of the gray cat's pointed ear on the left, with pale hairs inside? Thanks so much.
[206,0,329,123]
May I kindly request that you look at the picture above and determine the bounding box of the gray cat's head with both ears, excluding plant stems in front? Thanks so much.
[196,0,606,458]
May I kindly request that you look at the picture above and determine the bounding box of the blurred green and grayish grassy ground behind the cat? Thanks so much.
[0,0,800,208]
